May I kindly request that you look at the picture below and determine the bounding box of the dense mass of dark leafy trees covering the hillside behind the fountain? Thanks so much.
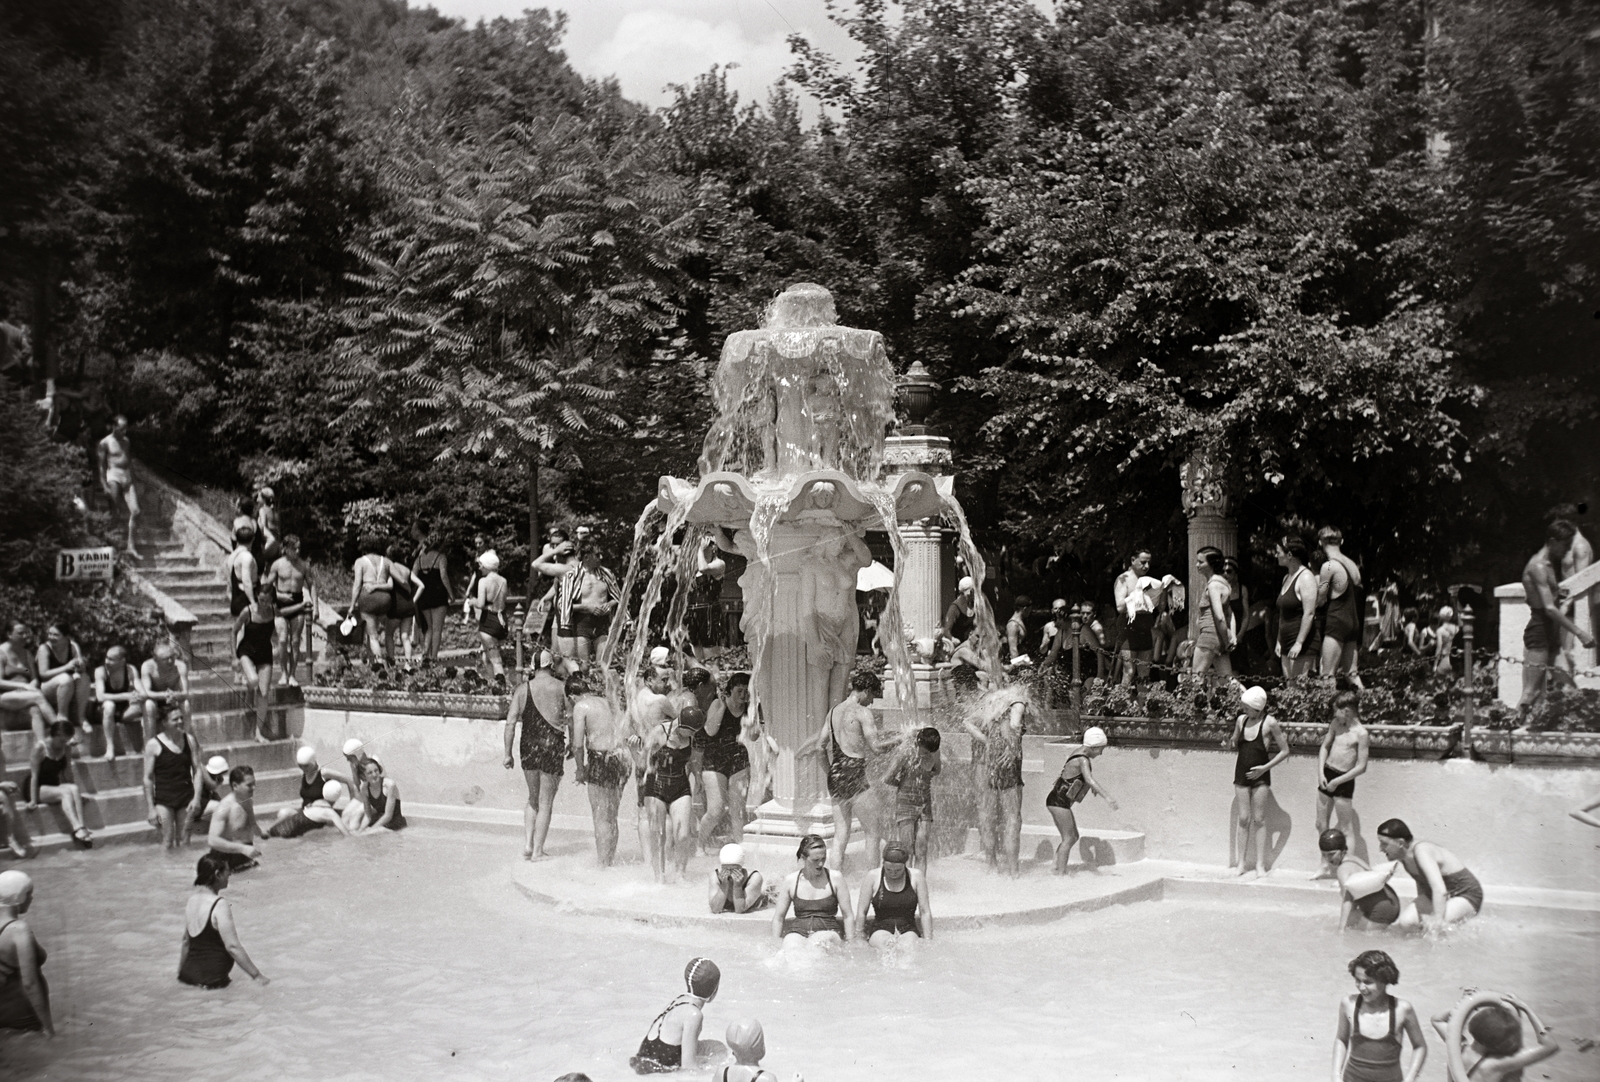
[0,0,1600,605]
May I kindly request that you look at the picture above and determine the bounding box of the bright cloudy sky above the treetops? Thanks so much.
[413,0,853,106]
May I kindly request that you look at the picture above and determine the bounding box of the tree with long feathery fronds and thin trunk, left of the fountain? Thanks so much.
[341,109,693,586]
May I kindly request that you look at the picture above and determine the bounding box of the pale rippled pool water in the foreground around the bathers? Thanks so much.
[0,828,1600,1082]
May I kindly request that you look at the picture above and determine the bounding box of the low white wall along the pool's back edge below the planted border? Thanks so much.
[298,707,1600,892]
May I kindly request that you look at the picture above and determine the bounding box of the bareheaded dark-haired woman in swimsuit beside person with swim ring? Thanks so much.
[1333,951,1427,1082]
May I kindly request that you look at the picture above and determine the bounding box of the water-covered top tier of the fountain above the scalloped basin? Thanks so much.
[699,282,894,482]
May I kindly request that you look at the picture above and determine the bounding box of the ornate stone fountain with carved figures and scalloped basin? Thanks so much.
[656,283,944,839]
